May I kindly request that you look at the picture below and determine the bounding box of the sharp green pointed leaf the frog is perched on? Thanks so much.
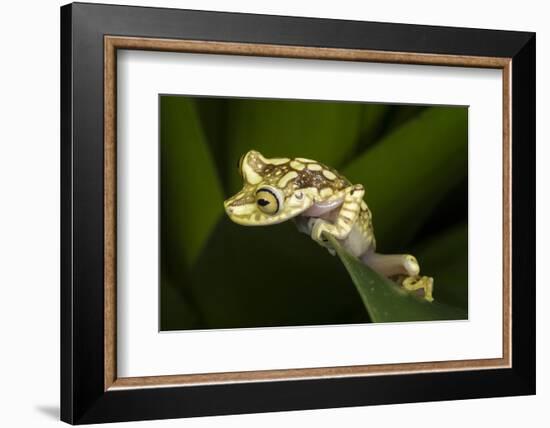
[326,235,468,322]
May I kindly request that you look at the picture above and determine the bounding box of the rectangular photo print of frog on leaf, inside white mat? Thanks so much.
[159,94,468,331]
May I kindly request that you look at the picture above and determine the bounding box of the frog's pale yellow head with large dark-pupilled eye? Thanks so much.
[224,150,318,226]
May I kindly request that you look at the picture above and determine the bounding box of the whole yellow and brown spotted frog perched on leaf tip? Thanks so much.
[224,150,434,302]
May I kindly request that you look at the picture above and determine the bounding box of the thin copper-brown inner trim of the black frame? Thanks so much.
[104,36,512,391]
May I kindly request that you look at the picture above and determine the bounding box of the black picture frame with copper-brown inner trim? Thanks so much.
[61,3,536,424]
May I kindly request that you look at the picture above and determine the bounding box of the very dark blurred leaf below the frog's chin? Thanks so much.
[187,216,368,328]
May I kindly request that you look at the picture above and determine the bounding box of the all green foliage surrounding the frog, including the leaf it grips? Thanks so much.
[160,96,468,330]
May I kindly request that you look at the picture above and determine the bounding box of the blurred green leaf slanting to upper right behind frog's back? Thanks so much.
[342,107,468,252]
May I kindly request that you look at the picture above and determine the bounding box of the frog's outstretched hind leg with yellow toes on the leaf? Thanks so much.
[361,251,433,302]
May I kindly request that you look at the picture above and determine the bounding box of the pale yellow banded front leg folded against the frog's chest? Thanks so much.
[311,184,365,250]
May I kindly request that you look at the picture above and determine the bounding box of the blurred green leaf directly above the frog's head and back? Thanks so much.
[227,99,362,192]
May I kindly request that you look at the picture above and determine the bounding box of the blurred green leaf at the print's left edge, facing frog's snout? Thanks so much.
[160,96,223,272]
